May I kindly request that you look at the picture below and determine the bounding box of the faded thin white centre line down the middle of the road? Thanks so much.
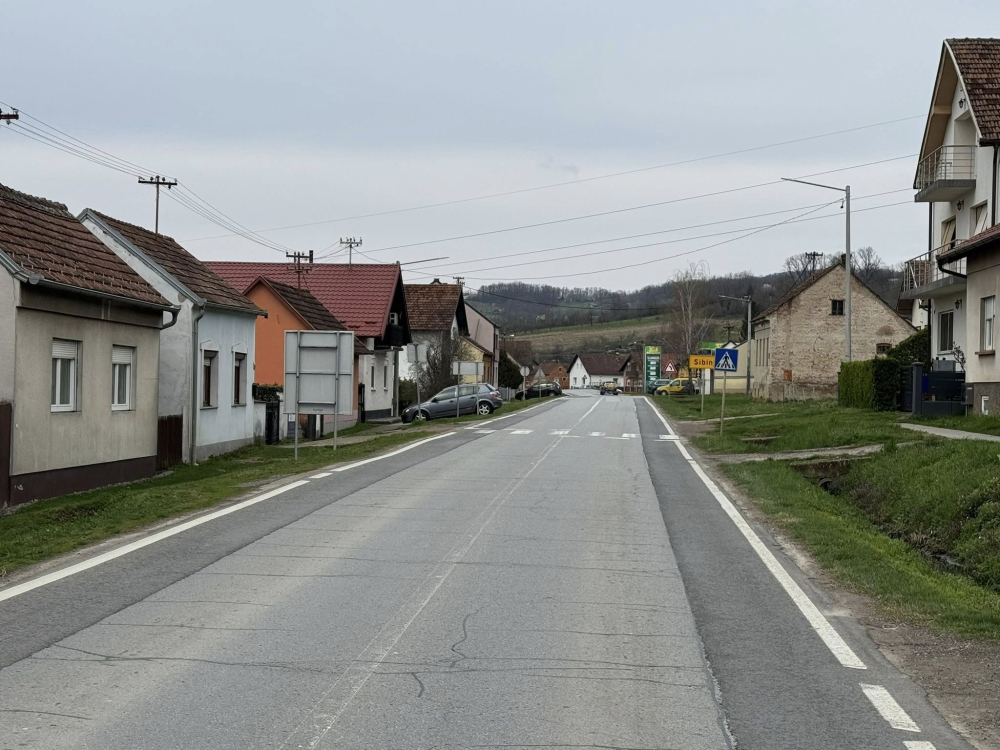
[278,438,562,750]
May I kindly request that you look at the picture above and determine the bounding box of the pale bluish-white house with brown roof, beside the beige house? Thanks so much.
[80,208,264,463]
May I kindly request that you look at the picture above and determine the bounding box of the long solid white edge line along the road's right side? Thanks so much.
[647,399,868,669]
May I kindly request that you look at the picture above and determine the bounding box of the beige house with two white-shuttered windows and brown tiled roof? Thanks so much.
[0,186,179,507]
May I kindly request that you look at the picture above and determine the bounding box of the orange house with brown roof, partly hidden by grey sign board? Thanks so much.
[245,277,371,427]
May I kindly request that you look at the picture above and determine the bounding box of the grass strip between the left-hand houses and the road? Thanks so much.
[0,430,438,577]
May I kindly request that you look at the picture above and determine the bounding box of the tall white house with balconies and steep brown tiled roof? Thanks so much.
[900,39,1000,369]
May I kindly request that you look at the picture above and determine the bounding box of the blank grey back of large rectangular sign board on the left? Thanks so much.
[284,331,354,415]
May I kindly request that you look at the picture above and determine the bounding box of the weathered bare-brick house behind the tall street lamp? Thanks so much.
[750,260,916,401]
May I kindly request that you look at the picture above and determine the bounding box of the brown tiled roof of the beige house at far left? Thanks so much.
[0,185,170,307]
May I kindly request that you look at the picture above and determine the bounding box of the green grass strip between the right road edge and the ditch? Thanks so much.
[721,462,1000,639]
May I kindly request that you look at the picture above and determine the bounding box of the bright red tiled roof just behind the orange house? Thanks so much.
[207,261,402,337]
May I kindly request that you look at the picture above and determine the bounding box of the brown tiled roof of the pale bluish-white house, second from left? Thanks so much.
[84,208,260,312]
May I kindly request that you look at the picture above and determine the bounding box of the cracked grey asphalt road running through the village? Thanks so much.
[0,392,969,750]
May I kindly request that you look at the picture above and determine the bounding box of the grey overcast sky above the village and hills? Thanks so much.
[0,0,1000,289]
